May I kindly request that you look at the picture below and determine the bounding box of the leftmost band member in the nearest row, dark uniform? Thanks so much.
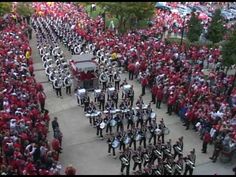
[119,148,131,175]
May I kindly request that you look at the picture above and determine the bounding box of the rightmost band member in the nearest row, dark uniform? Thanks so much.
[184,149,196,175]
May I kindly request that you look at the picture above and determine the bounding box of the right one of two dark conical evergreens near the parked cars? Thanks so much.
[207,9,225,43]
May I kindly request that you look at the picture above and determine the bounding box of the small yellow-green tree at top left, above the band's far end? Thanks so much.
[16,2,34,17]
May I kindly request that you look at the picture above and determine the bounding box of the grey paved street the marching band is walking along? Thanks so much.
[31,29,236,175]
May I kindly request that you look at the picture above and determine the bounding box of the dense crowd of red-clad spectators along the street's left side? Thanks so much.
[0,13,61,175]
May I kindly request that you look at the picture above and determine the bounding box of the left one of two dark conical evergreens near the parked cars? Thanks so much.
[187,12,202,42]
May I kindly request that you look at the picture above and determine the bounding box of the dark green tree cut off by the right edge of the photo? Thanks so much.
[222,29,236,67]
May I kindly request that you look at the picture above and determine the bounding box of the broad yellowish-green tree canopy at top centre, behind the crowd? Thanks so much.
[97,2,155,32]
